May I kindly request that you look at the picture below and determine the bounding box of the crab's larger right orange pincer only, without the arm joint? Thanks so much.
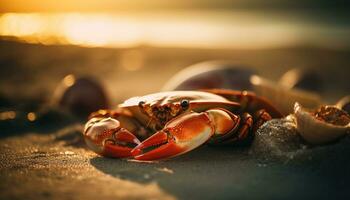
[131,112,215,160]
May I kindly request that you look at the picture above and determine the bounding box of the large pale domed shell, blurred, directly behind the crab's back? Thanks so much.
[162,61,256,91]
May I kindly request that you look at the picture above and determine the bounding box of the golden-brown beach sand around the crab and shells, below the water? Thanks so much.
[0,41,350,199]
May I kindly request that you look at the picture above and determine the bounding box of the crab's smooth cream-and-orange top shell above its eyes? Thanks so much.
[118,91,241,126]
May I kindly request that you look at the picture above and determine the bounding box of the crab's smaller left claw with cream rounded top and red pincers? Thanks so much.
[83,117,140,158]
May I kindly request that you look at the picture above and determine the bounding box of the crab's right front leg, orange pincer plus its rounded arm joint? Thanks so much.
[132,109,239,160]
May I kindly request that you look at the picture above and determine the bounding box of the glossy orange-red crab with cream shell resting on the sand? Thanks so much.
[83,89,282,161]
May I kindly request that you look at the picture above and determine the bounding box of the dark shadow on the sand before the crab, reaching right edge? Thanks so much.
[90,141,349,199]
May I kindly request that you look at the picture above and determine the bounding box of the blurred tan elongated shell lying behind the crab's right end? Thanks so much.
[251,76,323,115]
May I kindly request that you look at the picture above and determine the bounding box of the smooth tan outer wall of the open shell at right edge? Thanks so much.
[294,103,350,144]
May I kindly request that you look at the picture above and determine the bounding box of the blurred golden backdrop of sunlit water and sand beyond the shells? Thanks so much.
[0,0,350,112]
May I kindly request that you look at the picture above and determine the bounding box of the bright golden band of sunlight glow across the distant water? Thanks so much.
[0,12,350,48]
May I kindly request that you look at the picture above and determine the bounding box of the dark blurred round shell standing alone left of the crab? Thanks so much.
[51,74,109,117]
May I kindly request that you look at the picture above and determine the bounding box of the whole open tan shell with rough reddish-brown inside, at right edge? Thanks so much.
[294,103,350,144]
